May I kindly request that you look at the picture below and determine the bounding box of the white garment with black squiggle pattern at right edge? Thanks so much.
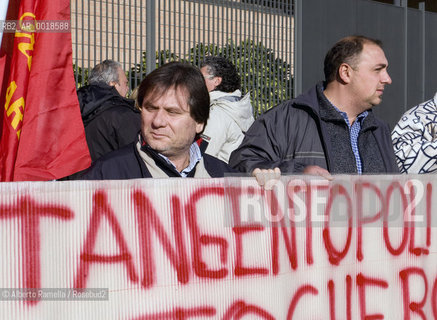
[391,93,437,173]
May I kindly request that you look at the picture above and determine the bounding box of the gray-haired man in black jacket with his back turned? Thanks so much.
[77,60,141,161]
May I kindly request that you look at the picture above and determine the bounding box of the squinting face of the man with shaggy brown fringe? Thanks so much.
[141,88,204,161]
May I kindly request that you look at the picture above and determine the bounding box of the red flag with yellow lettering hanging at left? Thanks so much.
[0,0,91,181]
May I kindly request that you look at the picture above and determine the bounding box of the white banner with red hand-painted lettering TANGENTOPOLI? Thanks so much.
[0,175,437,320]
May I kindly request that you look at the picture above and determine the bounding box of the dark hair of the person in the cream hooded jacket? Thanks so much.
[200,56,241,92]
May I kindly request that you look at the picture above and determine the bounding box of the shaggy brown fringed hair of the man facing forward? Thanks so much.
[137,61,210,126]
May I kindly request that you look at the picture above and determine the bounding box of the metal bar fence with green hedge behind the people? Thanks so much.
[71,0,294,115]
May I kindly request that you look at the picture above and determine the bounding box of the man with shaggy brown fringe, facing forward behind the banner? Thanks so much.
[82,62,234,180]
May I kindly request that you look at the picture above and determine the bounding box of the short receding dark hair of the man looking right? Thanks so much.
[323,35,382,83]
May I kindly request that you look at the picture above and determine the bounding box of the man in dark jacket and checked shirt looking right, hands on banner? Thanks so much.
[229,36,398,184]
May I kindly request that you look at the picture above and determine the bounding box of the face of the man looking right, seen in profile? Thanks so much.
[350,43,391,110]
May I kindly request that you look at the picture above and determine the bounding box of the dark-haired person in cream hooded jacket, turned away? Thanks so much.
[200,56,254,163]
